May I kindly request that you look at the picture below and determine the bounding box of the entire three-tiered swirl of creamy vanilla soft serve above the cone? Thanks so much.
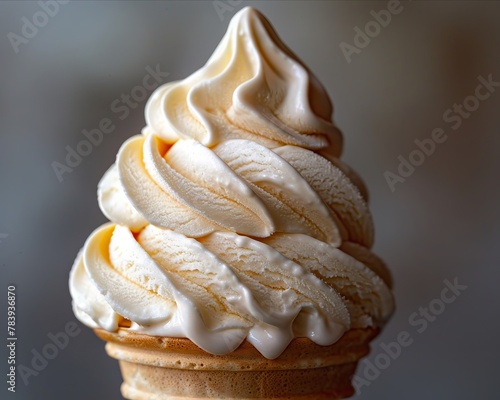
[70,8,394,359]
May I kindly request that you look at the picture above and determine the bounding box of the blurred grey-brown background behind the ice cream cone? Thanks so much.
[0,0,500,400]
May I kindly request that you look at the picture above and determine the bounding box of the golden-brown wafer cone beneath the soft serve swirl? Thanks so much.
[95,328,378,400]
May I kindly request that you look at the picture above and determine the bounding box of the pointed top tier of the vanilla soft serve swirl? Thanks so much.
[145,7,342,156]
